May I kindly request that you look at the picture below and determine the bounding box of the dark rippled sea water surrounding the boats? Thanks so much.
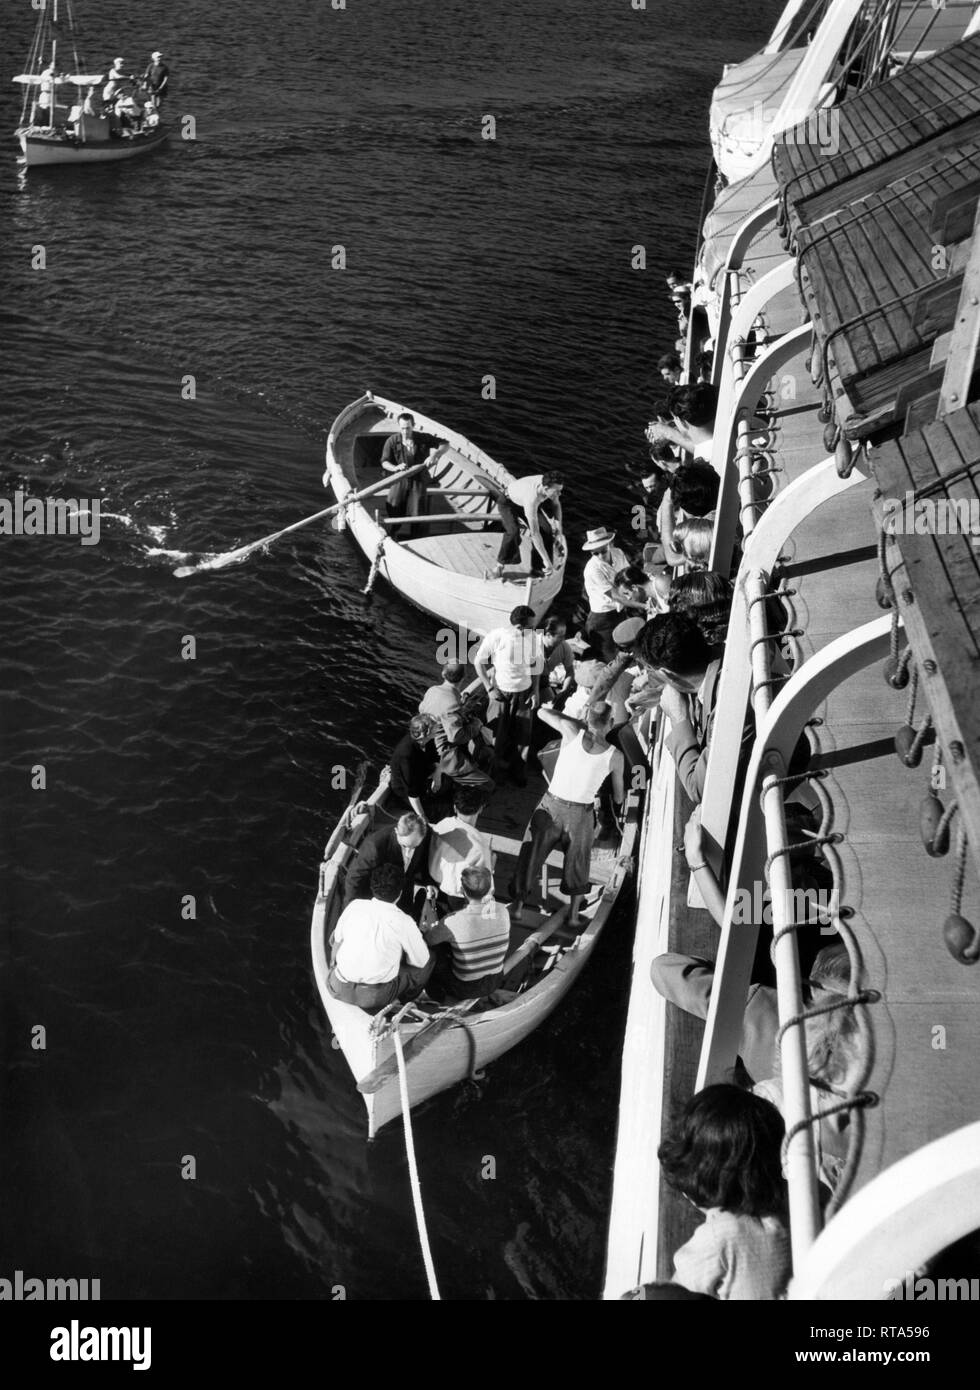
[0,0,778,1300]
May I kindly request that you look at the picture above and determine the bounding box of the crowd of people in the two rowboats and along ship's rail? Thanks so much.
[331,277,860,1300]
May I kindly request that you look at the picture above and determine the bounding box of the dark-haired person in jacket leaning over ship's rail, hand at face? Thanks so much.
[638,613,721,802]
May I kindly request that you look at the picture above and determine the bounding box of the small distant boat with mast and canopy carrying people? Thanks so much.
[14,0,167,168]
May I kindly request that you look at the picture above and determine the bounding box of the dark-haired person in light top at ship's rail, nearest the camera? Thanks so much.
[658,1084,791,1301]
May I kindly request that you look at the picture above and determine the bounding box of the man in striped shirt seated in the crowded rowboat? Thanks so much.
[427,866,510,999]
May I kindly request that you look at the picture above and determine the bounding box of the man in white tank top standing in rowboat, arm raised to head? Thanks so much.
[510,701,624,927]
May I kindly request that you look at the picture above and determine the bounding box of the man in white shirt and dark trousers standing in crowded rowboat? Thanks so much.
[473,603,545,787]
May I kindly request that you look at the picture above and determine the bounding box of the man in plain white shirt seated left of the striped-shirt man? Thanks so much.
[327,863,435,1013]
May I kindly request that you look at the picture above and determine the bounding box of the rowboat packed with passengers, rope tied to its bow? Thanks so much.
[311,774,639,1138]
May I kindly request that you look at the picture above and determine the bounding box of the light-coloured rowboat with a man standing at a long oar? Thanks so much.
[324,391,566,637]
